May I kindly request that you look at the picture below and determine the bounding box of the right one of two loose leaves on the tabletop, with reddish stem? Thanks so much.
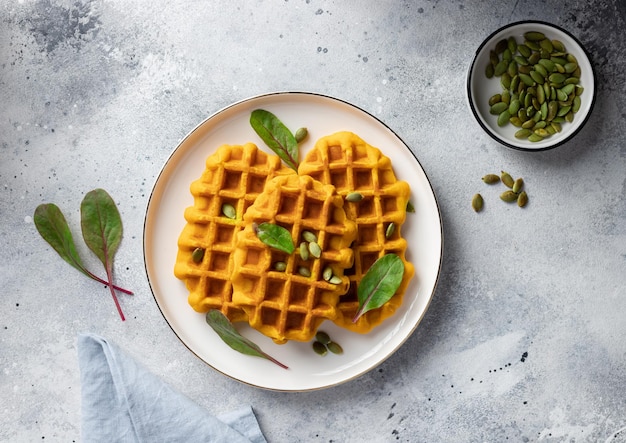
[80,189,124,320]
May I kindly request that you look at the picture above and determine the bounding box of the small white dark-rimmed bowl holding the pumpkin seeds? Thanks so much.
[467,21,596,151]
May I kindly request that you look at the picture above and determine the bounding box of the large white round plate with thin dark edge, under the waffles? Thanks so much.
[144,92,443,391]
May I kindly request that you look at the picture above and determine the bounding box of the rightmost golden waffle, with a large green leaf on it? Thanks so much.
[298,132,415,333]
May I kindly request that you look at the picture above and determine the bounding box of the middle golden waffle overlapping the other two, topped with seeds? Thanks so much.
[233,175,356,343]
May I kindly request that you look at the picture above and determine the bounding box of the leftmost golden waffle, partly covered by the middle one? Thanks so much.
[174,143,295,322]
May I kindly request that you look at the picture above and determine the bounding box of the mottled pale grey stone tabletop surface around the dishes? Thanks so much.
[0,0,626,442]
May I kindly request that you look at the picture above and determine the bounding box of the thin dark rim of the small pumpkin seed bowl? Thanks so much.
[466,20,596,152]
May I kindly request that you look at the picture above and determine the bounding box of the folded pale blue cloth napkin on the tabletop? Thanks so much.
[78,334,266,443]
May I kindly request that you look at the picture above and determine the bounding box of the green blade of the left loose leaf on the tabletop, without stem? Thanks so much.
[33,203,90,276]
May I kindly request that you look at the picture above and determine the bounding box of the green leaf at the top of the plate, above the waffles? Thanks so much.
[250,109,299,171]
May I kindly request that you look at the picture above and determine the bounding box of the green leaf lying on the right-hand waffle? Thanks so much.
[352,254,404,322]
